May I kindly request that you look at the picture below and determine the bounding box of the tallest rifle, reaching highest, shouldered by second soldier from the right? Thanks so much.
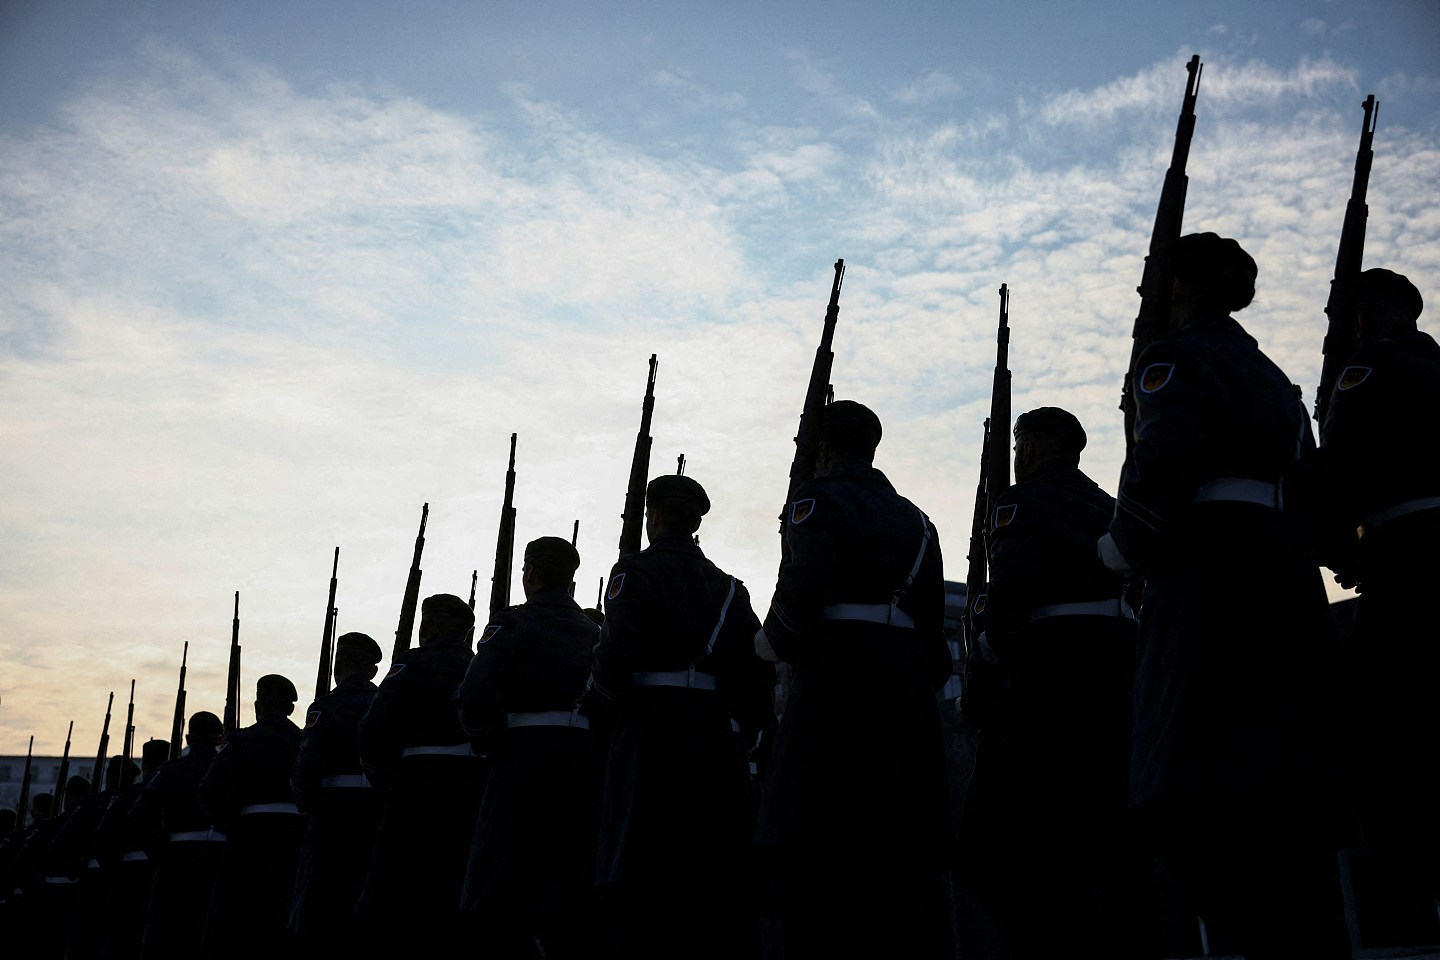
[1117,53,1201,456]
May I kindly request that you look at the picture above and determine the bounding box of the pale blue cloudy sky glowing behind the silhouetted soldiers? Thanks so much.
[0,0,1440,756]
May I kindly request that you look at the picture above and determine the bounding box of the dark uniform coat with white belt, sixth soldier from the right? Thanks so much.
[455,581,599,959]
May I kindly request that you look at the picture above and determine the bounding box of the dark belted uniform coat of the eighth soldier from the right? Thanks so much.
[289,673,380,950]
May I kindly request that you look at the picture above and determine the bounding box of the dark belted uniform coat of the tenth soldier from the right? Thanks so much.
[130,746,225,960]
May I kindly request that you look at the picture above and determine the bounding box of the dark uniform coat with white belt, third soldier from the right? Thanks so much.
[959,460,1139,956]
